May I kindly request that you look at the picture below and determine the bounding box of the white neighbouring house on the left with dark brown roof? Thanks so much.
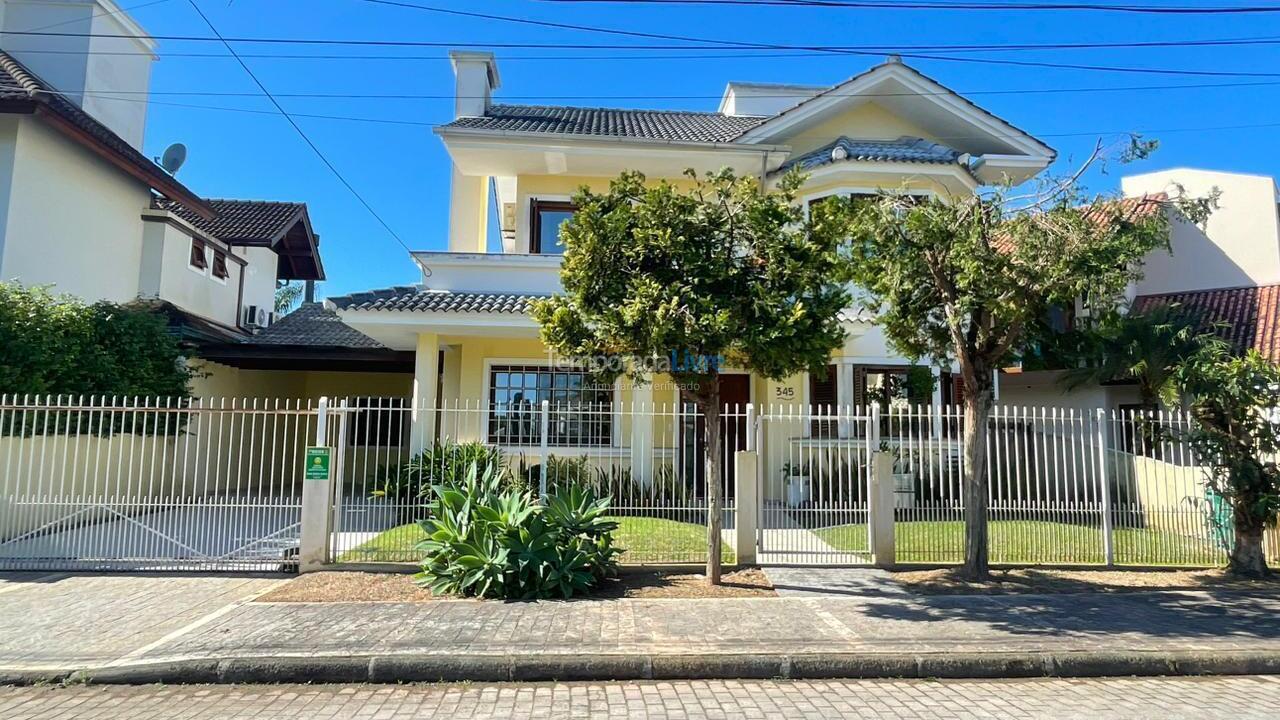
[0,0,407,396]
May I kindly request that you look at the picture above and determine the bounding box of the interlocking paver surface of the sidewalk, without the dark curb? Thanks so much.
[0,575,1280,674]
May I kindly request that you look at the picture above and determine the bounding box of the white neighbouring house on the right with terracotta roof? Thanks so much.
[1000,168,1280,410]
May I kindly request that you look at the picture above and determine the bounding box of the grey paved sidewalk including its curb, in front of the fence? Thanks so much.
[0,570,1280,682]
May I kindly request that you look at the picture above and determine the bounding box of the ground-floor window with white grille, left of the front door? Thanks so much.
[489,365,613,447]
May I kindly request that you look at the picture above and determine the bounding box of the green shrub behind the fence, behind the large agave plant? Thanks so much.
[372,439,509,502]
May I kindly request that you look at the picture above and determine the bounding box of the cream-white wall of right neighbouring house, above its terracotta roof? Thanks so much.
[1120,168,1280,295]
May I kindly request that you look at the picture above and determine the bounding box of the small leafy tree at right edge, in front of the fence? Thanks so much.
[1175,341,1280,578]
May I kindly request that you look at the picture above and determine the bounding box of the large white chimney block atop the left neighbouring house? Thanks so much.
[0,0,156,150]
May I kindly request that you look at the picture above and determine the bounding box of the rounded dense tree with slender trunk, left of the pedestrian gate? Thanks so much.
[532,170,851,584]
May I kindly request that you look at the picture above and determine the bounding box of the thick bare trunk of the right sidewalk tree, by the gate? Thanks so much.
[960,370,995,580]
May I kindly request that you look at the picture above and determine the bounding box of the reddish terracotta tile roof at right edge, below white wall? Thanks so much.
[1133,284,1280,363]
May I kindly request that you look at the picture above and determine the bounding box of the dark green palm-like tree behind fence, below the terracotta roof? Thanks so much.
[1061,304,1207,407]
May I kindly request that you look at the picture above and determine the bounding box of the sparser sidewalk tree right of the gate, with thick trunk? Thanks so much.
[824,151,1207,579]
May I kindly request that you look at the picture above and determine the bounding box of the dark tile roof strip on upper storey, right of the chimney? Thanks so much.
[443,105,764,142]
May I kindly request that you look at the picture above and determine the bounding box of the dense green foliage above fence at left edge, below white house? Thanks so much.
[0,283,193,397]
